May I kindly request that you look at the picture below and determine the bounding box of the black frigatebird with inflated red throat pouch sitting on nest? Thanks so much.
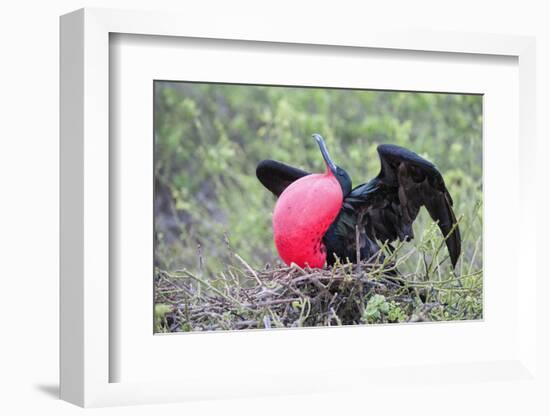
[256,134,460,268]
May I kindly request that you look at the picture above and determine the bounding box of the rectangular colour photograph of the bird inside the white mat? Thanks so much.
[152,80,484,334]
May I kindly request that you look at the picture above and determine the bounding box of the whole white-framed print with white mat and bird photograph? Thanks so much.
[61,9,537,406]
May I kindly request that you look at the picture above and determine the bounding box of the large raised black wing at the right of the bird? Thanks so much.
[350,144,461,267]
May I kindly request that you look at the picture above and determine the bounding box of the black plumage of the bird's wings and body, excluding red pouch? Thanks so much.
[256,144,461,267]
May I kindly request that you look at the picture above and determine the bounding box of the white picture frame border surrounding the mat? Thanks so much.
[60,9,538,406]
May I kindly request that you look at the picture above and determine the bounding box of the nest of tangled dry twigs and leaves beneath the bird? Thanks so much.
[155,247,484,332]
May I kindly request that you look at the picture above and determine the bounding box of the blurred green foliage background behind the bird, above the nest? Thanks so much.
[154,81,482,273]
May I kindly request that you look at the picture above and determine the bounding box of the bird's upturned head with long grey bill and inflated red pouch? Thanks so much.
[273,134,351,268]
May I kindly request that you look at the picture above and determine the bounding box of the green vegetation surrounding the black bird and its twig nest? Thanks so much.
[155,82,483,331]
